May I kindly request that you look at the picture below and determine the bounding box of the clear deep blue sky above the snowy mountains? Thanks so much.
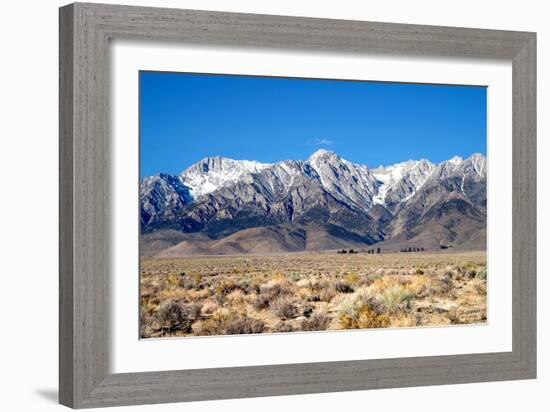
[139,71,487,176]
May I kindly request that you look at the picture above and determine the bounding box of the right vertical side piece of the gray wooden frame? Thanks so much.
[512,36,537,376]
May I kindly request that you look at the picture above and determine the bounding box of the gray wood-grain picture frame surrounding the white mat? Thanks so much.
[59,3,536,408]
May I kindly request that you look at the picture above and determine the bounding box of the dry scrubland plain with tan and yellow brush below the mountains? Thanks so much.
[140,252,487,338]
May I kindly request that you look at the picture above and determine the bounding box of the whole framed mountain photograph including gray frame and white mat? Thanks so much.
[60,3,536,408]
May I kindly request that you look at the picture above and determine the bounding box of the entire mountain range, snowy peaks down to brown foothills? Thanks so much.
[140,149,487,256]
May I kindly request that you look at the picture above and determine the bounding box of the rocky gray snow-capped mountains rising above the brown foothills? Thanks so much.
[140,150,486,249]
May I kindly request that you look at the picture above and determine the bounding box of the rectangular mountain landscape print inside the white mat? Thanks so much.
[139,71,487,338]
